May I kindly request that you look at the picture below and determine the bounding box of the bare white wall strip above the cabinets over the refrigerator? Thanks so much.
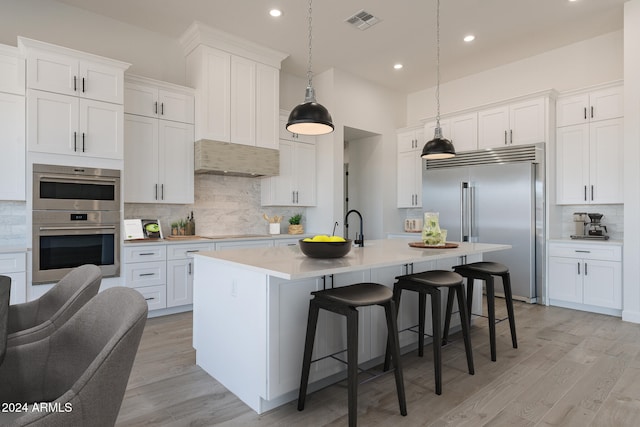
[406,31,623,126]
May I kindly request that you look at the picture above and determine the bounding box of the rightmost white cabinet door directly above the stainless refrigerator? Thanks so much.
[509,98,547,145]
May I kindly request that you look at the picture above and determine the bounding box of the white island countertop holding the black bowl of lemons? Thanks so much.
[194,239,511,280]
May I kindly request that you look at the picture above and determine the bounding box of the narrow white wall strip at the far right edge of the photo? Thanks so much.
[622,0,640,323]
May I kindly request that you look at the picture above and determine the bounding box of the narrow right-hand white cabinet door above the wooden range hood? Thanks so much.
[256,64,280,150]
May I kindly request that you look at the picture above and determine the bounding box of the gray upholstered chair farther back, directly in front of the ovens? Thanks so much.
[7,264,102,347]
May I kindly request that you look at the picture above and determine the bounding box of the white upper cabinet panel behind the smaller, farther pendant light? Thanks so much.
[418,113,478,153]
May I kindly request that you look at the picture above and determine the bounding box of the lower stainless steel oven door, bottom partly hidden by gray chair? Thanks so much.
[32,211,120,283]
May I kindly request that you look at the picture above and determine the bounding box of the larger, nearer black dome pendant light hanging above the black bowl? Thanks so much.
[287,0,333,135]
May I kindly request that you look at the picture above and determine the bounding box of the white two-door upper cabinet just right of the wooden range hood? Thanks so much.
[261,139,316,206]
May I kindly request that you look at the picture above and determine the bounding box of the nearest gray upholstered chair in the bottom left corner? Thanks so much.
[0,287,147,427]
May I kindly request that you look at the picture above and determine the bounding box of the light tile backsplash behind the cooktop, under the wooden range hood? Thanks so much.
[124,174,306,236]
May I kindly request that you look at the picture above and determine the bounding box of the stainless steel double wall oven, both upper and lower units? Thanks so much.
[32,164,120,283]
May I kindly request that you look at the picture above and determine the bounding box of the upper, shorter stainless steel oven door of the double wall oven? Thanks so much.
[33,164,120,211]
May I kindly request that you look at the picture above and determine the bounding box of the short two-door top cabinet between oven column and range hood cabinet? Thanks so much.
[124,75,194,124]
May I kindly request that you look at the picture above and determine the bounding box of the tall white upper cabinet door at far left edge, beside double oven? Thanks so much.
[0,93,26,201]
